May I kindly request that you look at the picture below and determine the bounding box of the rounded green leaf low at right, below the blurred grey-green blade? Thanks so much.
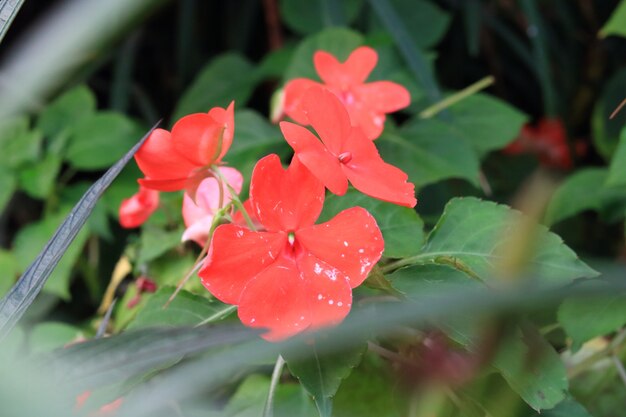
[492,329,568,415]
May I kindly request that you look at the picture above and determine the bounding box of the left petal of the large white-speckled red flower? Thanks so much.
[198,224,287,304]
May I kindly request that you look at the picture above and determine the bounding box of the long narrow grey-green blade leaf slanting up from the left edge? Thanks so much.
[0,122,156,340]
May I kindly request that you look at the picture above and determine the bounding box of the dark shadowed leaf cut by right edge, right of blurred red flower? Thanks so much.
[591,68,626,161]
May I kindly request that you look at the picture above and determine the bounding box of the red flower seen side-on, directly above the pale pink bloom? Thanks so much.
[135,103,235,191]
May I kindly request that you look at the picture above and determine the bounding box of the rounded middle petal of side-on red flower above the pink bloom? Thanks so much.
[172,113,225,166]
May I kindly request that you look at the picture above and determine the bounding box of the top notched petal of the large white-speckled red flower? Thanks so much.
[250,154,324,232]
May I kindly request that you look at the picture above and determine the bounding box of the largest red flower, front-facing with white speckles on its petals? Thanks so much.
[199,155,384,340]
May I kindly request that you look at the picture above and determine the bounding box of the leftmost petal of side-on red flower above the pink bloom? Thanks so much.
[135,129,196,182]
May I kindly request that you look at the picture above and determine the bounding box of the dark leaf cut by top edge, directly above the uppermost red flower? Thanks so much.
[279,0,363,35]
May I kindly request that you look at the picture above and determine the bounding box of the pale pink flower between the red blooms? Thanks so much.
[182,167,243,246]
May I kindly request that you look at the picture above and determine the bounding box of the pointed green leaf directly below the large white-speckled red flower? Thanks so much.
[285,343,364,417]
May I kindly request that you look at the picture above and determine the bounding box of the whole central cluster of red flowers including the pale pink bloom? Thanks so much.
[122,47,417,340]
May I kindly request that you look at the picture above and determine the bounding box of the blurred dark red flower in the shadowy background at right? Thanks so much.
[504,118,586,169]
